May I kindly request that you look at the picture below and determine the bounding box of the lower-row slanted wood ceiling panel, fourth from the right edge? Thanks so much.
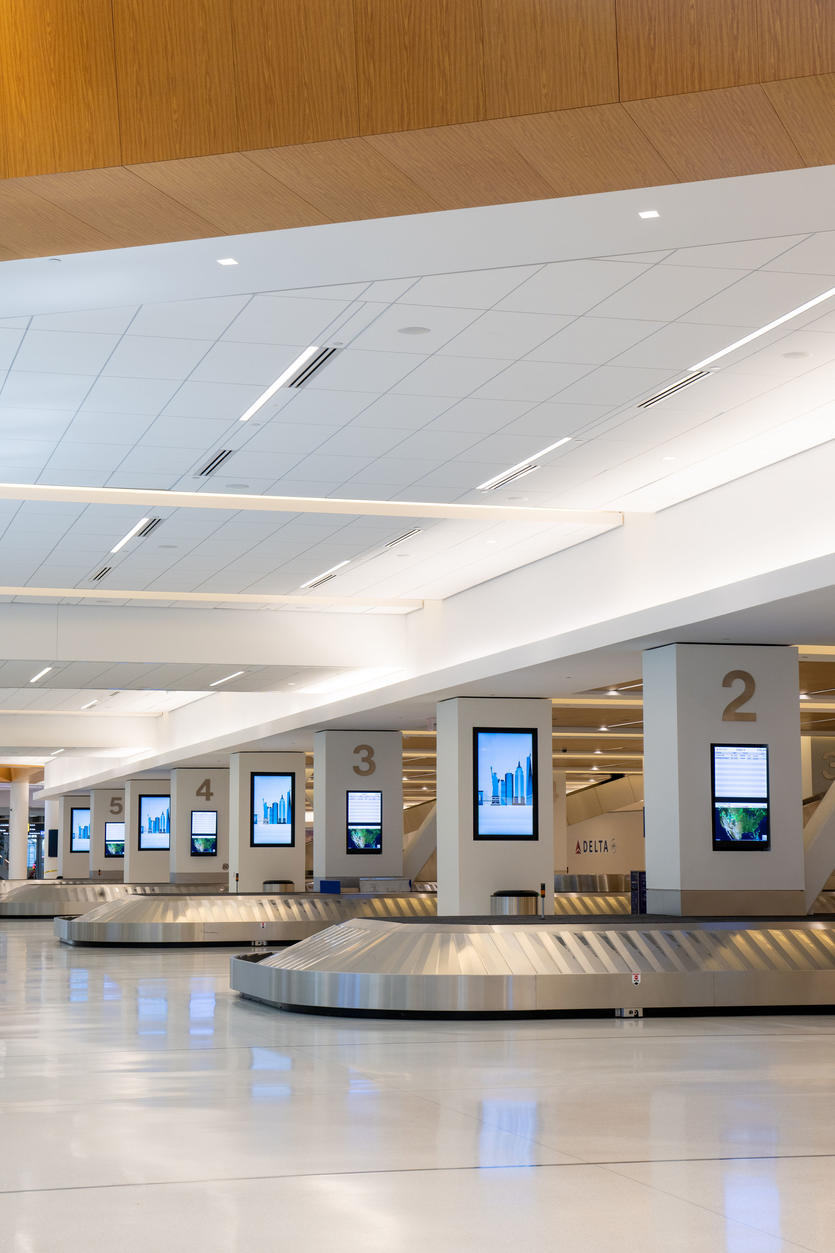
[366,123,554,209]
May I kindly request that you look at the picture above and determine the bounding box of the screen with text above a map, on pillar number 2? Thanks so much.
[711,744,771,852]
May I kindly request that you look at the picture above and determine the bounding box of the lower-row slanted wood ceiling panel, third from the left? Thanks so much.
[130,149,332,234]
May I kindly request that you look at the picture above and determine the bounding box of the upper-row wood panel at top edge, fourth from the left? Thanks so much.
[355,0,484,135]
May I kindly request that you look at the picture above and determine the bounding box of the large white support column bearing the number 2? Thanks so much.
[643,644,805,916]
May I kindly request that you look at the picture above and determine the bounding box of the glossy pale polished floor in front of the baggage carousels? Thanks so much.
[0,918,835,1253]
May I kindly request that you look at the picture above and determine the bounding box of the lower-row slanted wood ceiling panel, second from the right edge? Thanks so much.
[626,85,804,179]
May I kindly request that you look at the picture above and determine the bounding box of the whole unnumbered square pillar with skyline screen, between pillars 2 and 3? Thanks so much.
[438,697,554,915]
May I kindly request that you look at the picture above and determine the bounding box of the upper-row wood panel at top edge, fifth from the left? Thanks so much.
[483,0,618,118]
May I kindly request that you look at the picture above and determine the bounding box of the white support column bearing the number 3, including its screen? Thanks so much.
[313,730,402,880]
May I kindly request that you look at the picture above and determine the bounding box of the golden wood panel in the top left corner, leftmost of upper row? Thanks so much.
[0,0,120,178]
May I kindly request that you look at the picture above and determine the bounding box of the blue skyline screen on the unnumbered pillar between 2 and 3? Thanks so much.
[473,727,539,840]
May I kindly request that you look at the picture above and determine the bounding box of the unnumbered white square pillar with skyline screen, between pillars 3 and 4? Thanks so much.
[229,753,305,892]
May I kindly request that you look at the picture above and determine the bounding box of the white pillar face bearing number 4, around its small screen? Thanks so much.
[169,768,229,883]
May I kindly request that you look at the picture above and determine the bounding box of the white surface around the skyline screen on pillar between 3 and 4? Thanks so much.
[229,753,305,892]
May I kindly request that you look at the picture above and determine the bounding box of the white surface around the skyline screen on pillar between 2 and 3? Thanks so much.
[438,698,554,915]
